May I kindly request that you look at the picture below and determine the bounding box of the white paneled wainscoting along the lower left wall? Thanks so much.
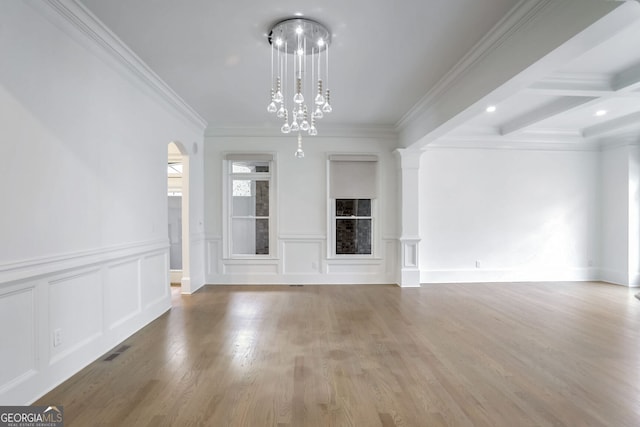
[0,239,171,405]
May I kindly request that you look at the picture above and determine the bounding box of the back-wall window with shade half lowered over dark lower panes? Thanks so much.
[329,155,378,257]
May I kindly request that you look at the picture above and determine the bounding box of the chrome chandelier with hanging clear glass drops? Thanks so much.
[267,18,332,158]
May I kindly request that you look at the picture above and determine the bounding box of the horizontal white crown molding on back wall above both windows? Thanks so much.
[204,125,398,141]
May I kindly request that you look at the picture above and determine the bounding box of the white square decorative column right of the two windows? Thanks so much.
[395,148,423,288]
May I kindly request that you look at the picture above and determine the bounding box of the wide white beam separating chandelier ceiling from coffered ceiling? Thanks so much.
[396,0,640,148]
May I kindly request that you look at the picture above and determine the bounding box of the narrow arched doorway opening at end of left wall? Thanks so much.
[167,141,191,293]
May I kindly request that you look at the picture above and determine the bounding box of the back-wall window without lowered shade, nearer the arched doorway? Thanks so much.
[227,154,273,256]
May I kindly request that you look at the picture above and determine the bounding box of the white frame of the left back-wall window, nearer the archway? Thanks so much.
[222,153,277,260]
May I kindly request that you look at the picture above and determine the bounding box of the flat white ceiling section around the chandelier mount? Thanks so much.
[81,0,518,128]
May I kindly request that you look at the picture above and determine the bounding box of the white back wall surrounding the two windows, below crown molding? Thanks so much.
[205,134,398,284]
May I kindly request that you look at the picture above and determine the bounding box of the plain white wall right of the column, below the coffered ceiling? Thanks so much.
[420,148,600,283]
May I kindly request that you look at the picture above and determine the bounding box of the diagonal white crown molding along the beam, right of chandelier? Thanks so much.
[395,0,555,131]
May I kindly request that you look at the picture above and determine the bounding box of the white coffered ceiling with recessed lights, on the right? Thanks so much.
[436,9,640,149]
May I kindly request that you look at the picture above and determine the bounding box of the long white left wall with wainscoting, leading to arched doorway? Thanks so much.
[0,1,203,405]
